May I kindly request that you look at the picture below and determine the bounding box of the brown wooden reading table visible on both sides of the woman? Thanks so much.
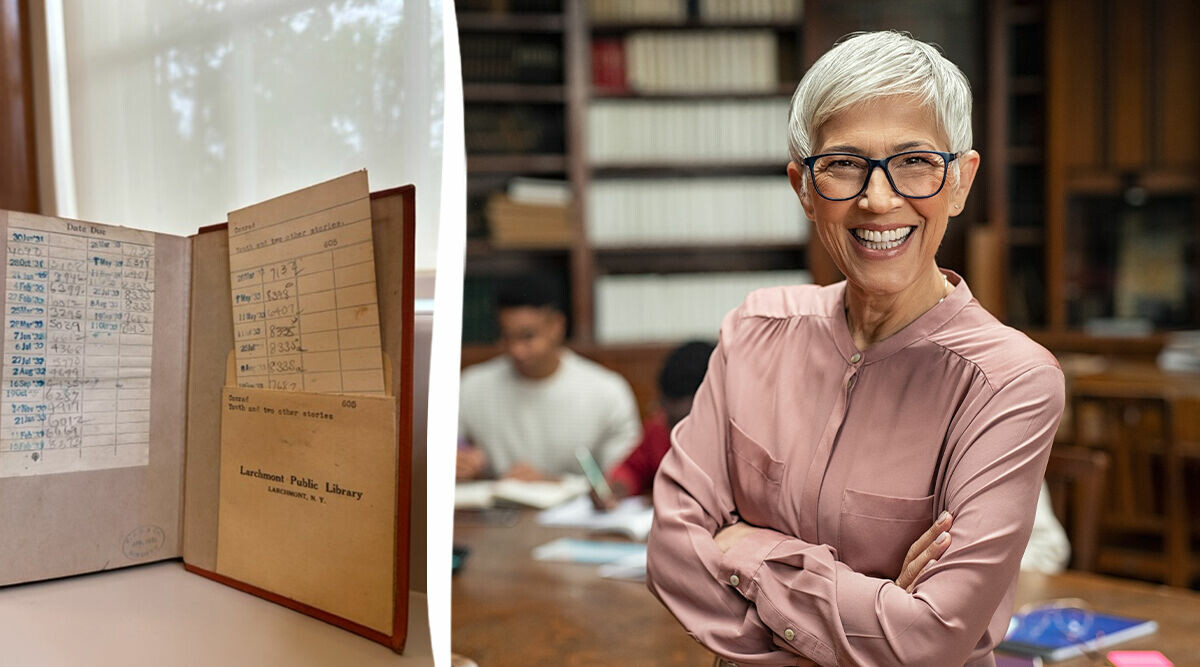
[450,510,1200,667]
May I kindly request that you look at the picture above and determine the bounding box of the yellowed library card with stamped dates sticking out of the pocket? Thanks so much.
[229,170,384,393]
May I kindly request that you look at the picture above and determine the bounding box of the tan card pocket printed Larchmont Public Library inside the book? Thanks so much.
[217,387,397,633]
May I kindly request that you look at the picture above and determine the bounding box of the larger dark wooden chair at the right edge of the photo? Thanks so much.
[1072,391,1200,587]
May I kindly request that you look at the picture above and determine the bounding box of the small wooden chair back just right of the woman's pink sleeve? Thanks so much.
[1045,445,1109,571]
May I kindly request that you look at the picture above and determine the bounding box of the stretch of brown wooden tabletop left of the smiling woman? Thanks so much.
[450,512,713,667]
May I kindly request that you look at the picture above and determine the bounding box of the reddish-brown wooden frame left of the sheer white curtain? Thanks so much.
[0,0,38,212]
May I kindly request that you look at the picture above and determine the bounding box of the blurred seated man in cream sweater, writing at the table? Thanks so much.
[457,281,638,480]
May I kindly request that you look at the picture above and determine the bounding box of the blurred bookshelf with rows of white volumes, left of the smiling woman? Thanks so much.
[458,0,808,345]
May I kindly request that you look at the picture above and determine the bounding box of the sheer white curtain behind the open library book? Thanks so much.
[46,0,444,269]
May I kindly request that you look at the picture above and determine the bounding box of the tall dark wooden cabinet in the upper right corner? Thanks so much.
[1045,0,1200,330]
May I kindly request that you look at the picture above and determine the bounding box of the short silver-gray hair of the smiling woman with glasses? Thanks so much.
[787,30,971,164]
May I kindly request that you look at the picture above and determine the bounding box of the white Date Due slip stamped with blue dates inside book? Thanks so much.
[0,214,155,477]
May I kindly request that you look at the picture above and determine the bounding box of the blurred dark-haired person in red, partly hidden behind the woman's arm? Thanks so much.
[608,341,714,498]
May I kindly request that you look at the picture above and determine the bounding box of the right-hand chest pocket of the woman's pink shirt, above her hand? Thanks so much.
[836,488,934,579]
